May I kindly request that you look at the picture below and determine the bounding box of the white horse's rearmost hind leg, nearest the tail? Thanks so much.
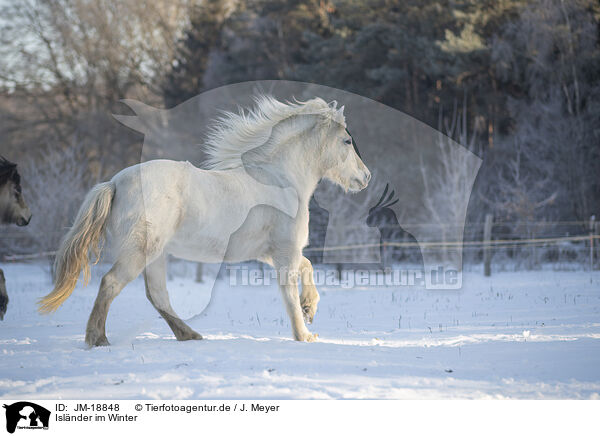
[85,251,146,347]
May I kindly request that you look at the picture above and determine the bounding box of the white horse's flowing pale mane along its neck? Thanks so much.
[204,95,346,170]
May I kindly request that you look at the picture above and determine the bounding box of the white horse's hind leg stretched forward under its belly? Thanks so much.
[144,254,202,341]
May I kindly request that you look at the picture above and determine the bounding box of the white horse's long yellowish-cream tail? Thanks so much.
[38,182,115,313]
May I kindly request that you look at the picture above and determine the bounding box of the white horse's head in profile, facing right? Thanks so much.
[322,106,371,192]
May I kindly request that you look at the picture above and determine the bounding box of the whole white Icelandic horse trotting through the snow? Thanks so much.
[39,96,371,346]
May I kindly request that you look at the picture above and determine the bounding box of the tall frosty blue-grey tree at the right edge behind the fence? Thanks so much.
[493,0,600,221]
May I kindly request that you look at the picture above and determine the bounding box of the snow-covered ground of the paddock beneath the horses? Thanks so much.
[0,263,600,399]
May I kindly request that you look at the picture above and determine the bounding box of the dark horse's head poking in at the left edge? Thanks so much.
[0,157,31,226]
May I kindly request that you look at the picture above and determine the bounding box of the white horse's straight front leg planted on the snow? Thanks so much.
[274,256,317,342]
